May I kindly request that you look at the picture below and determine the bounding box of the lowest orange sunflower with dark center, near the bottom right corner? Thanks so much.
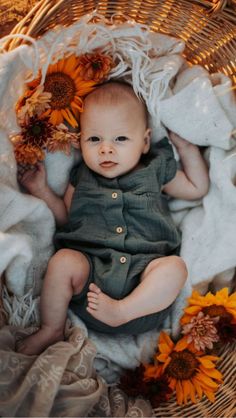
[144,332,222,405]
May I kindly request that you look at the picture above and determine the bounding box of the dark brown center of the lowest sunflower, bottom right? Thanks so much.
[166,350,198,379]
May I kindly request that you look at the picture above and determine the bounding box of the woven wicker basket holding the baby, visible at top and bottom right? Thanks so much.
[0,0,236,417]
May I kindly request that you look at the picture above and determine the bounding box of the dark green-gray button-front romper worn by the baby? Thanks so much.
[55,138,180,334]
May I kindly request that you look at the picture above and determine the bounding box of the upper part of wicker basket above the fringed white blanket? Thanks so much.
[2,0,236,85]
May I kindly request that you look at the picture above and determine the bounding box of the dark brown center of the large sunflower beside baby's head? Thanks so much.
[44,72,76,109]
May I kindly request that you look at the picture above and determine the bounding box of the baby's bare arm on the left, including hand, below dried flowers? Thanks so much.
[19,163,74,225]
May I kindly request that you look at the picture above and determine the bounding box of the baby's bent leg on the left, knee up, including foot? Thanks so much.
[17,249,90,355]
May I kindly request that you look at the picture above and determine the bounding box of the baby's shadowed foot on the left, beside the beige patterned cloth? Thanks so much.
[16,328,63,356]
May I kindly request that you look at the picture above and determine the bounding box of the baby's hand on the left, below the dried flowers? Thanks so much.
[18,163,47,198]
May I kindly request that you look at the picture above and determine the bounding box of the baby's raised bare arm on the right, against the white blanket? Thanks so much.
[163,132,209,200]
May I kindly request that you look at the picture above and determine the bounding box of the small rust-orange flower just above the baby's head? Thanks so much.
[78,52,113,83]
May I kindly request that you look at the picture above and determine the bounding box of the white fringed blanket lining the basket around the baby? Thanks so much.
[0,16,236,382]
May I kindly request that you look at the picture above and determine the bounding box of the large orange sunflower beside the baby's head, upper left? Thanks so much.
[25,55,96,128]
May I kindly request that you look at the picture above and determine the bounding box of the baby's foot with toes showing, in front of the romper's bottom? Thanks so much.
[87,283,128,327]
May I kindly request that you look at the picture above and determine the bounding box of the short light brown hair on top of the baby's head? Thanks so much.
[82,81,148,125]
